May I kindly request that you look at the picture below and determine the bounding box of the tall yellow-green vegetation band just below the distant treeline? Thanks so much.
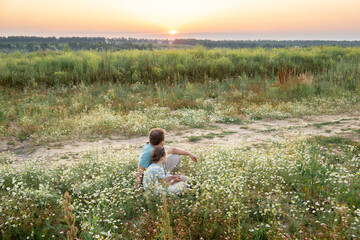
[0,47,360,89]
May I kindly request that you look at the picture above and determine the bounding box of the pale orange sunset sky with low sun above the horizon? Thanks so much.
[0,0,360,40]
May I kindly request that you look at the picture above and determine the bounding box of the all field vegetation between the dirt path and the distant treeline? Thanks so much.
[0,47,360,145]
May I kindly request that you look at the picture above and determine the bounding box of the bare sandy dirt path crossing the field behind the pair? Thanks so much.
[0,113,360,161]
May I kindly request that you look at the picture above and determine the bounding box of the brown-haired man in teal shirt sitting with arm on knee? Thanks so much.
[136,128,198,188]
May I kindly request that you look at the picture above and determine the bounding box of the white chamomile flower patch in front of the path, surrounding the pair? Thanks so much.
[0,139,360,239]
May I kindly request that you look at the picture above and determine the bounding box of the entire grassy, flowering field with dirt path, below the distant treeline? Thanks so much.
[0,47,360,239]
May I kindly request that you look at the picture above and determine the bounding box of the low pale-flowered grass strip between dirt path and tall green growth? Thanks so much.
[0,77,360,144]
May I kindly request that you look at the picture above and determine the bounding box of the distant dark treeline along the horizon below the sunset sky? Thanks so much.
[0,36,360,53]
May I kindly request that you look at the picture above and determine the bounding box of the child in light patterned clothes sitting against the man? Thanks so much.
[143,147,185,193]
